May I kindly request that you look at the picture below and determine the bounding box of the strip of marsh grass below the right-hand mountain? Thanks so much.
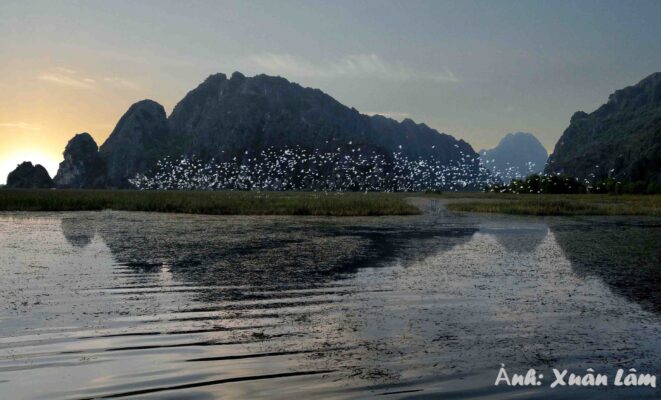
[448,194,661,216]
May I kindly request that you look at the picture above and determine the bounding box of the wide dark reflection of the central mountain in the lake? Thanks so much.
[62,213,477,300]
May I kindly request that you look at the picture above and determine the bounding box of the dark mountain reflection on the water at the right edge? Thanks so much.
[550,221,661,313]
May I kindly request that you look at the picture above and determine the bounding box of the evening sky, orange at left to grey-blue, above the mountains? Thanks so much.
[0,0,661,183]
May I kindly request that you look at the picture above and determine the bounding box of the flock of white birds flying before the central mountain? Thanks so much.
[129,143,500,192]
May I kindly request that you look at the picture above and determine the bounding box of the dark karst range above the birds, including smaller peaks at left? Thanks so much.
[56,72,479,187]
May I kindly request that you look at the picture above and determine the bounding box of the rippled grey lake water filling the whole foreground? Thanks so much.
[0,200,661,399]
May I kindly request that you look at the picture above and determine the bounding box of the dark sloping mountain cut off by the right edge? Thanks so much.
[546,72,661,182]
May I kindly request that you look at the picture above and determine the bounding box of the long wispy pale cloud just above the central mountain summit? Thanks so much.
[247,53,459,83]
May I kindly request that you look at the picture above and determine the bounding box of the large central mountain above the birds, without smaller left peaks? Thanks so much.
[169,72,474,161]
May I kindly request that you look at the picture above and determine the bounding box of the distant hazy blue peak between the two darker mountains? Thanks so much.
[480,132,548,182]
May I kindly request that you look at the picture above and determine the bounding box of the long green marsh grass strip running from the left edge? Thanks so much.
[0,189,420,216]
